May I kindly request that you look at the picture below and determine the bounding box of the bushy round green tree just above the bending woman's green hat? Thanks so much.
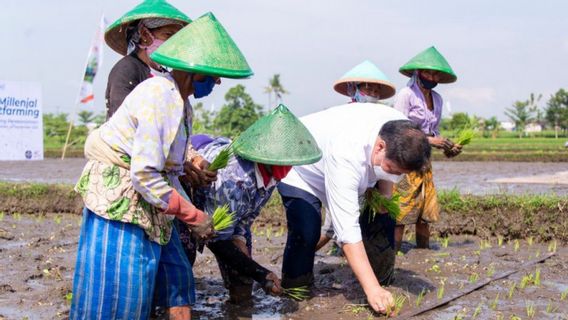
[213,84,263,137]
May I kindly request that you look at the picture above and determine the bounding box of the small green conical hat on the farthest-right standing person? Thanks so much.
[398,46,458,83]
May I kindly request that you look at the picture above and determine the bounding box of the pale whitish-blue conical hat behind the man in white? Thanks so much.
[333,60,396,99]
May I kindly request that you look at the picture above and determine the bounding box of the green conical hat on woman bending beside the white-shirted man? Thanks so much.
[233,104,322,166]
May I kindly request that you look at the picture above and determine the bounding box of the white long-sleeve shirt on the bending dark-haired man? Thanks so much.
[282,103,407,243]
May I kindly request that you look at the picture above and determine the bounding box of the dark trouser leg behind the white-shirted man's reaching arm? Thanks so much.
[359,211,396,286]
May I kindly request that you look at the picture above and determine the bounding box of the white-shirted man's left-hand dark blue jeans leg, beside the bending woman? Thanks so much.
[278,183,321,287]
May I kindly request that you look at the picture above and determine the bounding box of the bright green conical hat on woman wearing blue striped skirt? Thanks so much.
[150,12,253,78]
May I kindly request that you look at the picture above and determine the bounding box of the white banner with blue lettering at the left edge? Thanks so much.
[0,80,43,160]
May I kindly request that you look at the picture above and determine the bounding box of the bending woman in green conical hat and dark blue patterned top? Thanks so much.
[180,105,321,303]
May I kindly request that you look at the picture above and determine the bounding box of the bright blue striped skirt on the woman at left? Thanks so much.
[69,208,195,319]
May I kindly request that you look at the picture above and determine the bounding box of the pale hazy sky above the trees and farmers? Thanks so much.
[0,0,568,120]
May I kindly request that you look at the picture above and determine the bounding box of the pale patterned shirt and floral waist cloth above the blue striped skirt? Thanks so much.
[76,76,192,244]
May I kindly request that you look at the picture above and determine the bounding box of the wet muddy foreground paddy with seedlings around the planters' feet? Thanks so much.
[0,214,568,320]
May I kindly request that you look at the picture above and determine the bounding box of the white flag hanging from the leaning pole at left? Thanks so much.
[78,15,107,105]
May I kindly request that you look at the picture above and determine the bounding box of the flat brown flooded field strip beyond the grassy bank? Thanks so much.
[0,158,568,195]
